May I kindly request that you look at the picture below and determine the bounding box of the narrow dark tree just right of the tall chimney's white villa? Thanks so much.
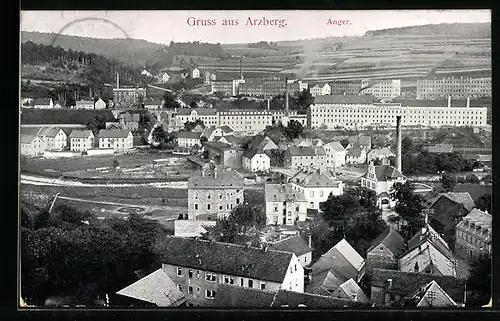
[391,181,424,240]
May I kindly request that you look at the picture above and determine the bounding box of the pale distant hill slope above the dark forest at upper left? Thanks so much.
[21,31,165,66]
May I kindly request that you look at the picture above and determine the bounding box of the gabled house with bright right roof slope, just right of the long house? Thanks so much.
[305,239,365,295]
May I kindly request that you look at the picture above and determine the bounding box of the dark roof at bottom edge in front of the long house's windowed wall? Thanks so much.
[213,284,276,308]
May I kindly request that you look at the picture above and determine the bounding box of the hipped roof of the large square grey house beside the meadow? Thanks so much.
[188,167,244,189]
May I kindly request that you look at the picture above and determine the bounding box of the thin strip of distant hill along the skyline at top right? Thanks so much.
[365,22,491,38]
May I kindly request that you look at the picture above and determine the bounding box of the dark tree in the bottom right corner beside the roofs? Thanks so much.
[467,255,491,306]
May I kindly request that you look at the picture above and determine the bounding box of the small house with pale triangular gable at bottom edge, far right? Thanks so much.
[393,280,465,308]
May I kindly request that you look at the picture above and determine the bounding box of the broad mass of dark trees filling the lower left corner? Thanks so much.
[21,201,166,306]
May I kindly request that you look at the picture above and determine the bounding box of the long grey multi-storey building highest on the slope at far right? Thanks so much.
[417,77,491,99]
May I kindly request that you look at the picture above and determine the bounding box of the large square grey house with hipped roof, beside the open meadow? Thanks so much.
[188,166,244,220]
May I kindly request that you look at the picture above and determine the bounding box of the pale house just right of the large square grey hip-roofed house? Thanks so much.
[264,184,307,225]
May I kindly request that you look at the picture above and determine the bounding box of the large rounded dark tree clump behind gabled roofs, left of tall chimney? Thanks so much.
[312,187,386,255]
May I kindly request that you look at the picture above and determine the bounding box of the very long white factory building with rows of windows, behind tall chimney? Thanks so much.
[308,95,487,129]
